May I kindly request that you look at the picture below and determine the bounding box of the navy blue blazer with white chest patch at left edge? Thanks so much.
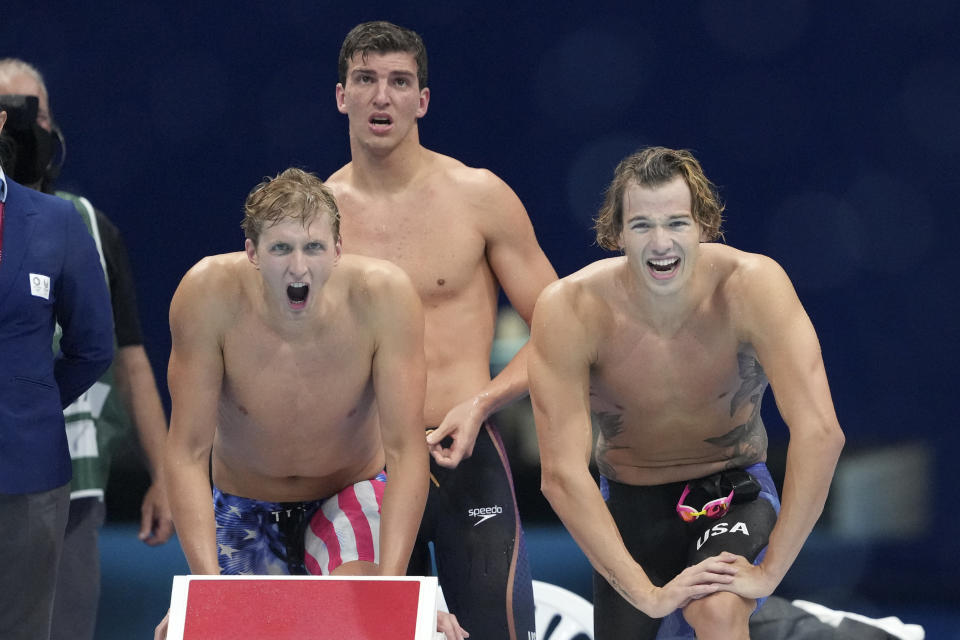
[0,175,113,494]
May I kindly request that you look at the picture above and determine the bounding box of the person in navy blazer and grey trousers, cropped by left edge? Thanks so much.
[0,98,113,640]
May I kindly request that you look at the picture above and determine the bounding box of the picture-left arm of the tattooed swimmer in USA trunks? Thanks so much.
[528,281,654,611]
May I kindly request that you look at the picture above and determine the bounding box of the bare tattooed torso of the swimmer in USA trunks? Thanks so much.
[568,249,768,485]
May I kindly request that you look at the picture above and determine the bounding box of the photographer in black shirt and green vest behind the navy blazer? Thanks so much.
[0,58,173,640]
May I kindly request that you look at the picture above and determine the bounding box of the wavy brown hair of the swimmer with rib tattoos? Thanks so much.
[593,147,724,251]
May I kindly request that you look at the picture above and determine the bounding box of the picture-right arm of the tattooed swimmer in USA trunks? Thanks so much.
[734,257,844,597]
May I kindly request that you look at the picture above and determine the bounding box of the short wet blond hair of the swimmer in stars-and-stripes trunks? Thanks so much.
[240,168,340,246]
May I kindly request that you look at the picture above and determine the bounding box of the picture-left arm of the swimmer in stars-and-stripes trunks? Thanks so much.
[164,267,223,574]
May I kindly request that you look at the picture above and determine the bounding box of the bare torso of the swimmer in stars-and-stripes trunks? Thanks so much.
[213,254,384,501]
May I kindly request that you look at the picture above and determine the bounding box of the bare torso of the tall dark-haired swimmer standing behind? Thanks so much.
[328,153,498,426]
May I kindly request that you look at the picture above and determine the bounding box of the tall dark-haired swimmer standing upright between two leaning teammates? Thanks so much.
[328,22,556,640]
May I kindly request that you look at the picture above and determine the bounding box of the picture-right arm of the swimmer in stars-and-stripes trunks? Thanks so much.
[371,269,430,576]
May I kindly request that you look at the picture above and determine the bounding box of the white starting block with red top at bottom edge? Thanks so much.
[167,576,442,640]
